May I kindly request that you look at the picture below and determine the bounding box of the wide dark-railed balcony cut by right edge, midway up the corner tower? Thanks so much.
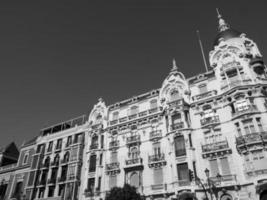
[236,131,267,153]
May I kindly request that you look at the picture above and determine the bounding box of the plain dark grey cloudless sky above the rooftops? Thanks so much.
[0,0,267,146]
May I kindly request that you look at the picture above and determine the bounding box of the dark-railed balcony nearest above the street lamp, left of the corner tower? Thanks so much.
[202,140,232,158]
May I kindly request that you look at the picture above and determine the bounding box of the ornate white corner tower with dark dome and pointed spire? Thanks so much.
[209,10,266,92]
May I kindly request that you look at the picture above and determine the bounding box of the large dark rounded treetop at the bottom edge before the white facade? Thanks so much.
[105,184,142,200]
